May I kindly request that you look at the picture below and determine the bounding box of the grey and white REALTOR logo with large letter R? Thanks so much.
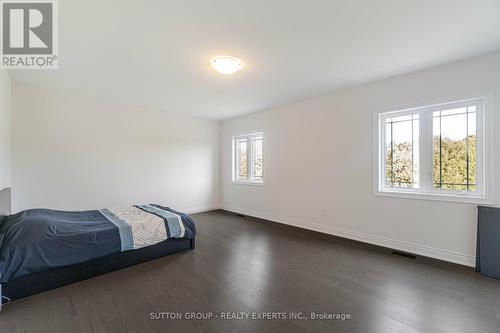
[0,0,58,69]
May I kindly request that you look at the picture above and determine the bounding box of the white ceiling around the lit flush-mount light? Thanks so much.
[10,0,500,119]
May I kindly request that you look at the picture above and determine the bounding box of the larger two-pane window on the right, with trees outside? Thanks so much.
[375,98,492,202]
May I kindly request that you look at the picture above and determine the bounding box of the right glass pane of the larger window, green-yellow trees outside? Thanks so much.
[433,107,476,191]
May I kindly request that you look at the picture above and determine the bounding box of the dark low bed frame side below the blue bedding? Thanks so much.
[0,238,195,311]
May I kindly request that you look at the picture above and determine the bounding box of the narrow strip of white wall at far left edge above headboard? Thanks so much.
[0,70,11,190]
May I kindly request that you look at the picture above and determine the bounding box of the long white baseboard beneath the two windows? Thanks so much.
[222,206,476,267]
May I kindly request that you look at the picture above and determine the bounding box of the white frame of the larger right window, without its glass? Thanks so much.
[373,92,494,204]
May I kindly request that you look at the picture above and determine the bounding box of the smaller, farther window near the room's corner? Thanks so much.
[233,132,264,184]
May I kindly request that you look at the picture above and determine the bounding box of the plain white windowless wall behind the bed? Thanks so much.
[12,85,220,211]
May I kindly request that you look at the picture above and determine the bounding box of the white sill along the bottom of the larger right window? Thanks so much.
[373,190,494,205]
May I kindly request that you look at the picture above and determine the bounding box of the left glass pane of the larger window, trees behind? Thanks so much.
[385,114,420,188]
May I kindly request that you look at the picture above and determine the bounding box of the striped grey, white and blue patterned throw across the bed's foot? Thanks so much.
[99,204,194,252]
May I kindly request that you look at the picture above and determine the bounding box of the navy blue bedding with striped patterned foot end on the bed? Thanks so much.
[0,204,196,283]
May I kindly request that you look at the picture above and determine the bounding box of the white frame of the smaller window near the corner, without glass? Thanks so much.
[231,130,266,185]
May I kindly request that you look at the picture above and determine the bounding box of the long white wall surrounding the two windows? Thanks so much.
[221,53,500,266]
